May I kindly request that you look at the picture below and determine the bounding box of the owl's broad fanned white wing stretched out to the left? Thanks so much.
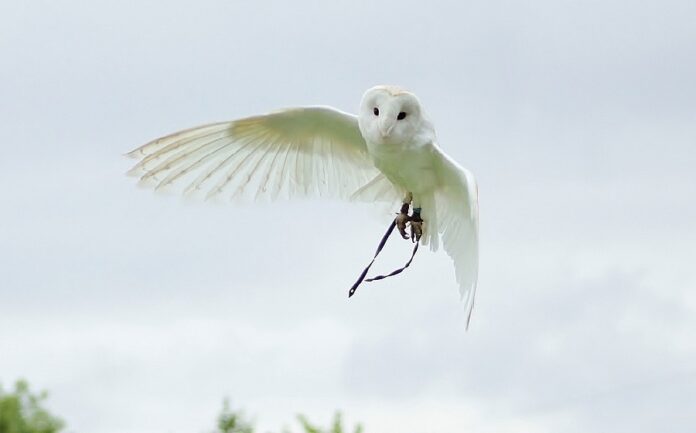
[128,107,380,200]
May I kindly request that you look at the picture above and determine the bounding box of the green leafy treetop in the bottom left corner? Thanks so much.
[0,380,64,433]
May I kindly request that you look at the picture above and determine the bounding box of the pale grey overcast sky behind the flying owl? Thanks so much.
[0,0,696,433]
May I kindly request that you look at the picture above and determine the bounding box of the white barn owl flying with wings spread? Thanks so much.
[128,85,478,327]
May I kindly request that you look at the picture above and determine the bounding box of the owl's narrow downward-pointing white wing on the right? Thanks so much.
[434,146,478,328]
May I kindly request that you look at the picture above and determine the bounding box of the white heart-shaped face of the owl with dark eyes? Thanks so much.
[358,86,422,145]
